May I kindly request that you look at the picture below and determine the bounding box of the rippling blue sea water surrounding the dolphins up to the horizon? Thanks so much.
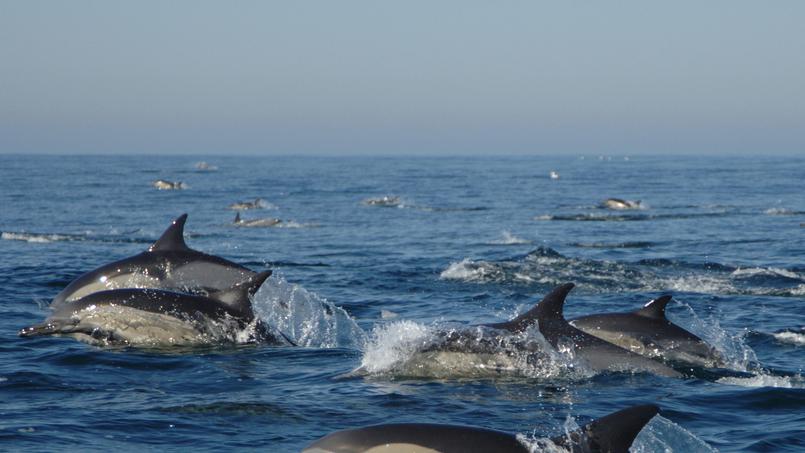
[0,155,805,452]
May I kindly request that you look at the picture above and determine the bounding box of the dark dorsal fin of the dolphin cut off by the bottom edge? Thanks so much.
[551,404,660,453]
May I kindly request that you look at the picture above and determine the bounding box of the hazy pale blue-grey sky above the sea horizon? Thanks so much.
[0,0,805,154]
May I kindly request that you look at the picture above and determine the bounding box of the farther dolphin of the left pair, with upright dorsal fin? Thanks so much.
[51,214,255,309]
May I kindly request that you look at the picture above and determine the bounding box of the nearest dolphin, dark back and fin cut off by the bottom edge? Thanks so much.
[302,404,659,453]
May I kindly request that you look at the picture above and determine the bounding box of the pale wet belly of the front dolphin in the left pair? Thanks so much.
[56,305,239,346]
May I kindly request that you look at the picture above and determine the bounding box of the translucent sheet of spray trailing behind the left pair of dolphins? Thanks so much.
[254,273,366,349]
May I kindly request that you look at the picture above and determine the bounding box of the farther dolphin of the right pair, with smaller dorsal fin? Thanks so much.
[570,295,726,368]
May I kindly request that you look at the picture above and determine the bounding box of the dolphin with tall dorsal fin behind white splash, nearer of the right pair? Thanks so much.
[486,283,682,377]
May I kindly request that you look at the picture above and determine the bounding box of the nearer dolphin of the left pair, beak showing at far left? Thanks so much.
[19,271,288,346]
